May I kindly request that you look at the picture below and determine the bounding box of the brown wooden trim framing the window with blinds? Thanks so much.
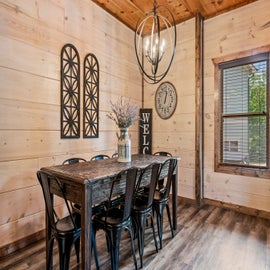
[213,49,270,179]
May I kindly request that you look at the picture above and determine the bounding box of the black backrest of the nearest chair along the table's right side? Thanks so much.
[109,167,138,221]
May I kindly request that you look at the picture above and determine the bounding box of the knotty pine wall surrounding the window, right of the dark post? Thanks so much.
[204,0,270,212]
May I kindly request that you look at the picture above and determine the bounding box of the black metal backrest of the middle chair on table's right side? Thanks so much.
[136,163,161,207]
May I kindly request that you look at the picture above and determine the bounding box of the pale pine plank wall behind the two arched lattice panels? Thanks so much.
[0,0,142,253]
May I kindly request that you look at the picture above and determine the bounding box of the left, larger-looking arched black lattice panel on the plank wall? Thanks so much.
[61,44,80,138]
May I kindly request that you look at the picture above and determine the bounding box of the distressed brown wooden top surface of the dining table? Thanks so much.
[41,154,179,184]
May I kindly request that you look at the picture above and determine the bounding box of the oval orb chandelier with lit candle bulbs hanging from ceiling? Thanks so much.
[134,0,176,84]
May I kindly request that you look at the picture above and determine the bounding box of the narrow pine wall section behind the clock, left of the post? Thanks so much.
[144,19,196,199]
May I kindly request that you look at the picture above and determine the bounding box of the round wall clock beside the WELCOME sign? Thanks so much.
[155,82,177,119]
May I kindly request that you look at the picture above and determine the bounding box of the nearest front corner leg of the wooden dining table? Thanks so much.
[81,183,92,270]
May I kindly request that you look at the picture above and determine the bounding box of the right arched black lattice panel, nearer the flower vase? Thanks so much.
[83,53,99,138]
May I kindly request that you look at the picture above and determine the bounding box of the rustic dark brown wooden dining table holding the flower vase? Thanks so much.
[41,154,179,269]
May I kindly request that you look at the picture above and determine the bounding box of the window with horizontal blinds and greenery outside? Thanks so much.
[215,53,270,177]
